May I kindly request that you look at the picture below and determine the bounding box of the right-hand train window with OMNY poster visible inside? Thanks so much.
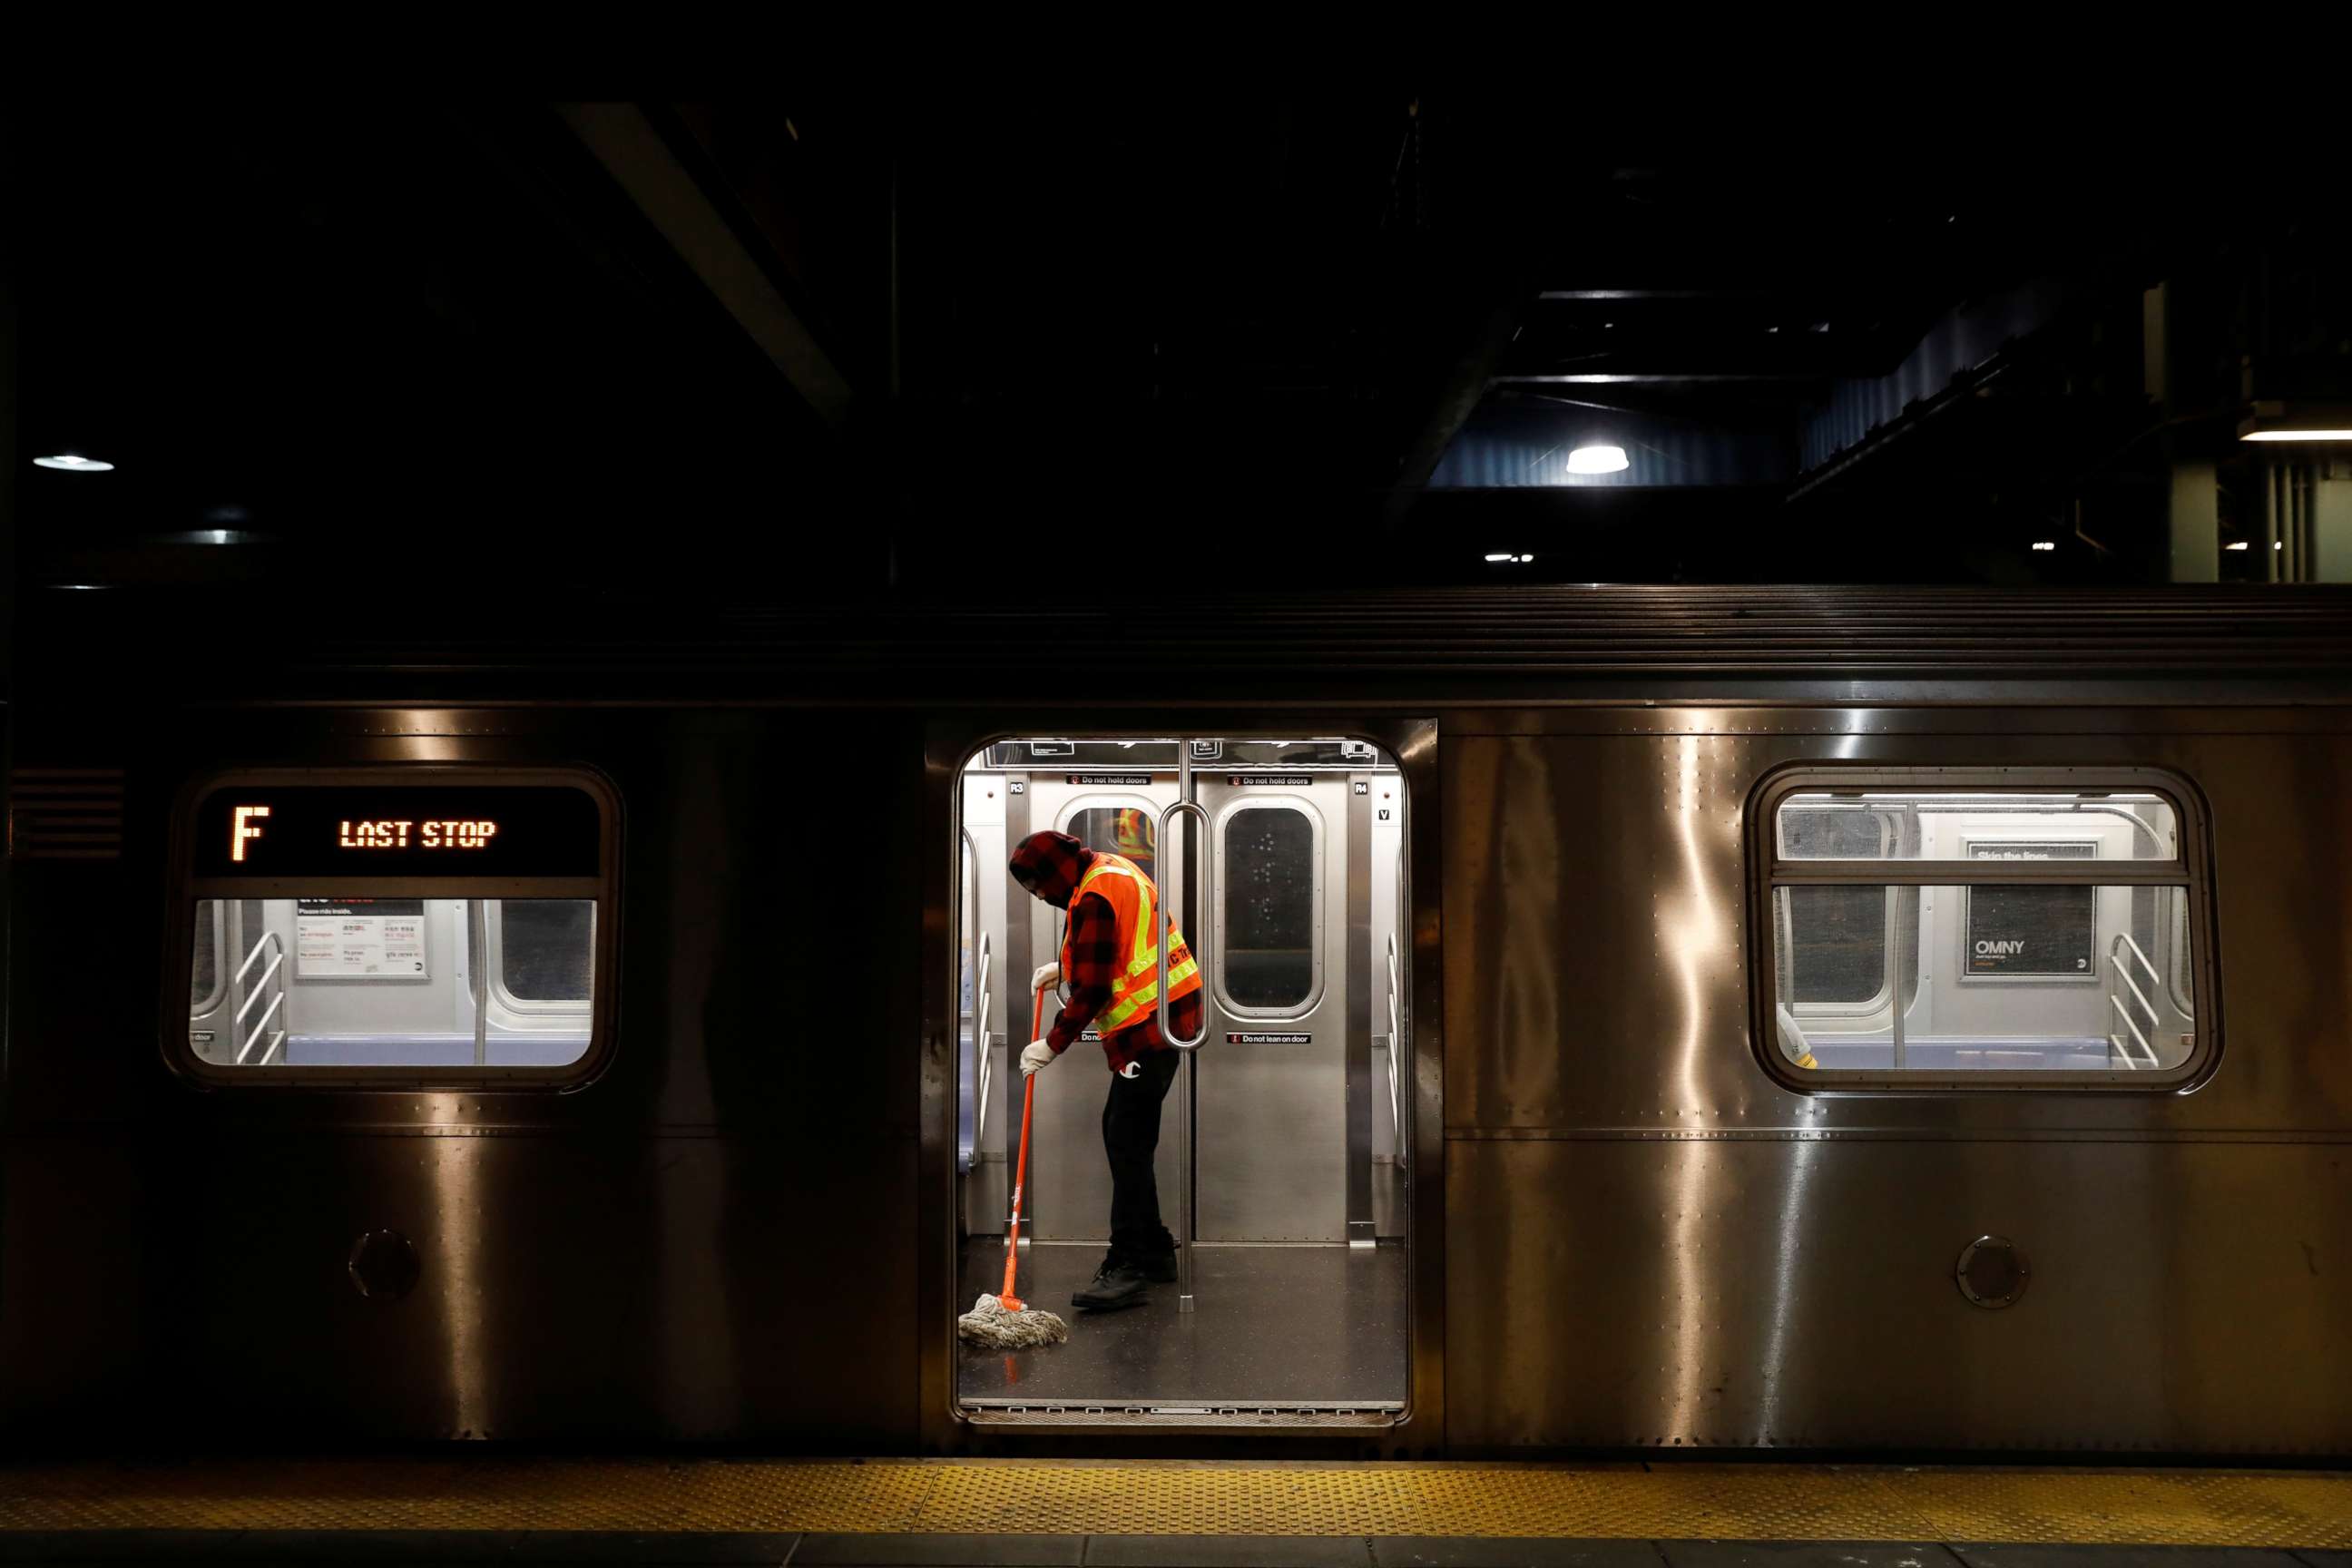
[1755,769,2210,1086]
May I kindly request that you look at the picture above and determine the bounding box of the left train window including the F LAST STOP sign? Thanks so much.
[174,769,614,1083]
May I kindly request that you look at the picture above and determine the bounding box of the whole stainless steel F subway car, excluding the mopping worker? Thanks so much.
[0,588,2352,1457]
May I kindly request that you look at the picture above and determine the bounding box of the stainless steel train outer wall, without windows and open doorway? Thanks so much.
[0,590,2352,1457]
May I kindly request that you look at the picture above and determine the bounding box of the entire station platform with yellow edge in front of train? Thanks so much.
[0,1455,2352,1568]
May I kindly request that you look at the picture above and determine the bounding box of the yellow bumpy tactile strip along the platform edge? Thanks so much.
[0,1455,2352,1547]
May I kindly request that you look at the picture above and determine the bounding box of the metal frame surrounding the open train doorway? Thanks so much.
[913,710,1446,1457]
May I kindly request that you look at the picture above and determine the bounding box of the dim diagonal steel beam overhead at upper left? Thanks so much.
[557,103,851,430]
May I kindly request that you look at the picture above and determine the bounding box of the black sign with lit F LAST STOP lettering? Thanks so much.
[195,785,604,877]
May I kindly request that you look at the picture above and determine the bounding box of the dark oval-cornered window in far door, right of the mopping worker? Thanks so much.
[1219,801,1322,1018]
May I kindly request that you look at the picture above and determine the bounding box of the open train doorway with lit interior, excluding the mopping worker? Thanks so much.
[957,736,1411,1425]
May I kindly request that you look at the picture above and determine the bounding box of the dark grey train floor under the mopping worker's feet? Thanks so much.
[957,1237,1406,1410]
